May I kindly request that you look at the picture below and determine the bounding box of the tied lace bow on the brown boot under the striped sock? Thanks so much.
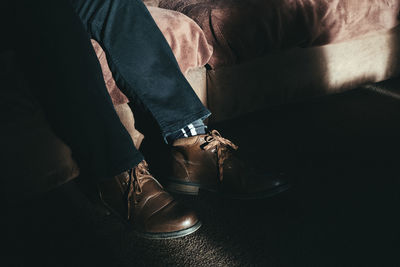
[204,130,239,182]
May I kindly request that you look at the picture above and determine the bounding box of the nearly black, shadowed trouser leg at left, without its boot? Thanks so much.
[14,0,143,182]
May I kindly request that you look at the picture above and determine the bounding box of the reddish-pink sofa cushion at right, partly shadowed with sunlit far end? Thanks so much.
[159,0,400,69]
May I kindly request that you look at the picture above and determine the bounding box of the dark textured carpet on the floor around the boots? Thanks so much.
[2,79,400,266]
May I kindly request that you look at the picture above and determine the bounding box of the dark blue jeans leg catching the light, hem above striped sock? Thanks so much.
[70,0,210,140]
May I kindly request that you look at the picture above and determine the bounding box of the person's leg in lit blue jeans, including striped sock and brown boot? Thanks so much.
[69,0,287,198]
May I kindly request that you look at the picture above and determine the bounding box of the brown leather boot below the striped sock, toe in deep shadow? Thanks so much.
[166,130,289,199]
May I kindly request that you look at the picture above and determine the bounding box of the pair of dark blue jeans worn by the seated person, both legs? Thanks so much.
[13,0,210,182]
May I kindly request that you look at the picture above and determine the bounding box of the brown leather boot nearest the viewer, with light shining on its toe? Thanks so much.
[98,161,201,239]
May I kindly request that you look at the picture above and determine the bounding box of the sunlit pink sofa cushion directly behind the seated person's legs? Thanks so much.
[92,7,212,105]
